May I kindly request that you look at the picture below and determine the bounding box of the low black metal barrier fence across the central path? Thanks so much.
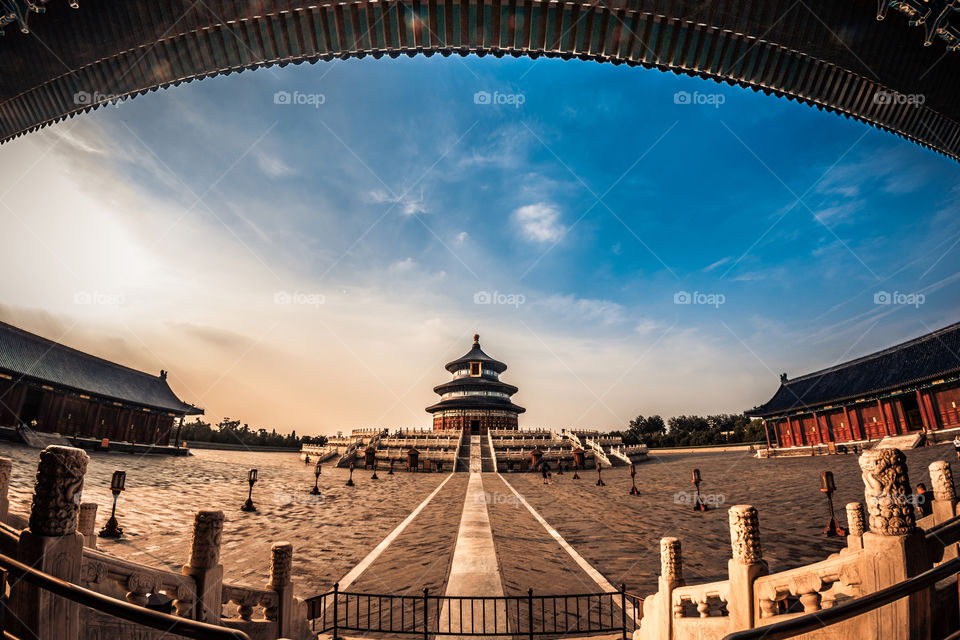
[306,585,643,640]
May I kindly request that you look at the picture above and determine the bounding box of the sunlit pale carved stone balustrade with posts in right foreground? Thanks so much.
[634,449,960,640]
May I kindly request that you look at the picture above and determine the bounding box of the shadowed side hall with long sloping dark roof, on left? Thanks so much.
[0,322,203,445]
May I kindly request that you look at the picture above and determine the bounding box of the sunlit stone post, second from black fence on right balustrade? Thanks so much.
[727,504,769,631]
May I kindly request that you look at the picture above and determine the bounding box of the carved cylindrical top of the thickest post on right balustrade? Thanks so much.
[860,449,916,536]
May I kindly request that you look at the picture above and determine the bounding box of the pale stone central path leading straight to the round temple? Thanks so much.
[438,468,507,637]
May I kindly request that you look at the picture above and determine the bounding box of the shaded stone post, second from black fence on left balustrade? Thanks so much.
[183,511,223,624]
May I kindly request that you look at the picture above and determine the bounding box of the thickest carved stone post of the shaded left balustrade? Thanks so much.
[11,445,89,640]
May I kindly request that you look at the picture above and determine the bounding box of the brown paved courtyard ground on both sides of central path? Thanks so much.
[0,444,956,597]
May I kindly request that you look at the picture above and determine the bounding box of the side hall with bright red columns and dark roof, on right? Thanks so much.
[745,323,960,447]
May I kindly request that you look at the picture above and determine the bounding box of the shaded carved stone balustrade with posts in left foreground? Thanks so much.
[0,446,311,640]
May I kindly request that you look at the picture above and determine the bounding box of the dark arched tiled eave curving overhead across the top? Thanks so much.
[0,0,960,159]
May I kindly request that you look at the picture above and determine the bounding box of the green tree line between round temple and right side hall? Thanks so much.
[610,413,766,447]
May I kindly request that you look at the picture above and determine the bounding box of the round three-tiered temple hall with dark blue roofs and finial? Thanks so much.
[427,335,526,435]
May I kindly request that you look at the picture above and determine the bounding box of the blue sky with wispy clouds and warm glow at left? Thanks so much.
[0,56,960,432]
